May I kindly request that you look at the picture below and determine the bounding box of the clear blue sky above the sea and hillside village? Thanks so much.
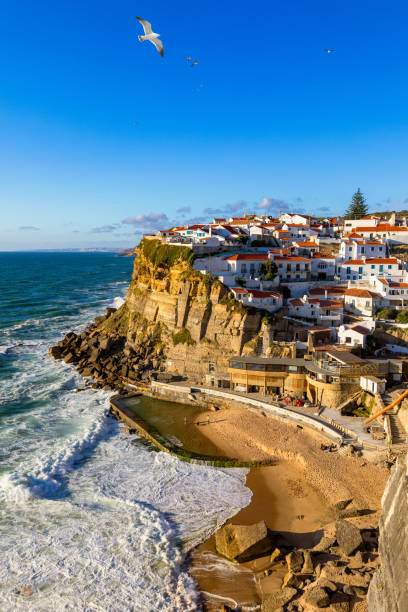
[0,0,408,250]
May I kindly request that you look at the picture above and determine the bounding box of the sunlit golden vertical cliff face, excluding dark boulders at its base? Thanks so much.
[113,248,262,376]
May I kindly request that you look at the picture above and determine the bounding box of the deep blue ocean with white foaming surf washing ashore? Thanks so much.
[0,252,251,612]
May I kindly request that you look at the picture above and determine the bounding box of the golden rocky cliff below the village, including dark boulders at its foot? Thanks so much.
[50,240,291,386]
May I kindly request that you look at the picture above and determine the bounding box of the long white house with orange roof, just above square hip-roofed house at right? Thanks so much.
[338,256,404,282]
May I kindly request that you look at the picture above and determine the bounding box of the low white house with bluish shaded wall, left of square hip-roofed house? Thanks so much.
[288,295,343,327]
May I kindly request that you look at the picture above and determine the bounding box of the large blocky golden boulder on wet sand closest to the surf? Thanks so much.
[215,521,271,563]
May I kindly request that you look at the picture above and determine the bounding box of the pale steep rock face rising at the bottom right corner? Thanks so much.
[367,458,408,612]
